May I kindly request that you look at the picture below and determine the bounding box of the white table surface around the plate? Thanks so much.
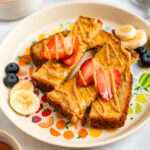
[0,0,150,150]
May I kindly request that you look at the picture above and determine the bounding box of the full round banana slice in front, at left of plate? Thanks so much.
[10,90,40,115]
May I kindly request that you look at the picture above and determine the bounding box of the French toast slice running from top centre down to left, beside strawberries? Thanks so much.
[32,16,102,92]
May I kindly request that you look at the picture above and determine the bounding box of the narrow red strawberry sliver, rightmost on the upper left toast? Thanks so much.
[63,37,79,66]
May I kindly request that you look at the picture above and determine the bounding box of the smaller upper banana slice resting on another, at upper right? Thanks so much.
[115,25,136,40]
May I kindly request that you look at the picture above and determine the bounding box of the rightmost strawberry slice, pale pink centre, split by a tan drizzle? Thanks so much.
[96,69,121,101]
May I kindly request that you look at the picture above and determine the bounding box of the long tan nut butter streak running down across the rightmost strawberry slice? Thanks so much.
[106,43,120,112]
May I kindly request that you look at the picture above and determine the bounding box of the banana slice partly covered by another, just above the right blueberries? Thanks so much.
[121,30,147,49]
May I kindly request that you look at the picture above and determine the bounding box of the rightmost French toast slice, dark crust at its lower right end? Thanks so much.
[89,42,138,128]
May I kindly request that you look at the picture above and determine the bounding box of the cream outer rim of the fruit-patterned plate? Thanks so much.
[0,0,150,148]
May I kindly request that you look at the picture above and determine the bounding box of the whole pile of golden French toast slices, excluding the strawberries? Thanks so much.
[31,16,138,128]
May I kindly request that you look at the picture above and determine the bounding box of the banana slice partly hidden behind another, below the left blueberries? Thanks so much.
[9,80,34,97]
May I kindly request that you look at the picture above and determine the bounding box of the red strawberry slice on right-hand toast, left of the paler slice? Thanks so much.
[77,58,94,86]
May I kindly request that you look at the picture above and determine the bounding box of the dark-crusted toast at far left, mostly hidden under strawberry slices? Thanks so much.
[30,30,69,68]
